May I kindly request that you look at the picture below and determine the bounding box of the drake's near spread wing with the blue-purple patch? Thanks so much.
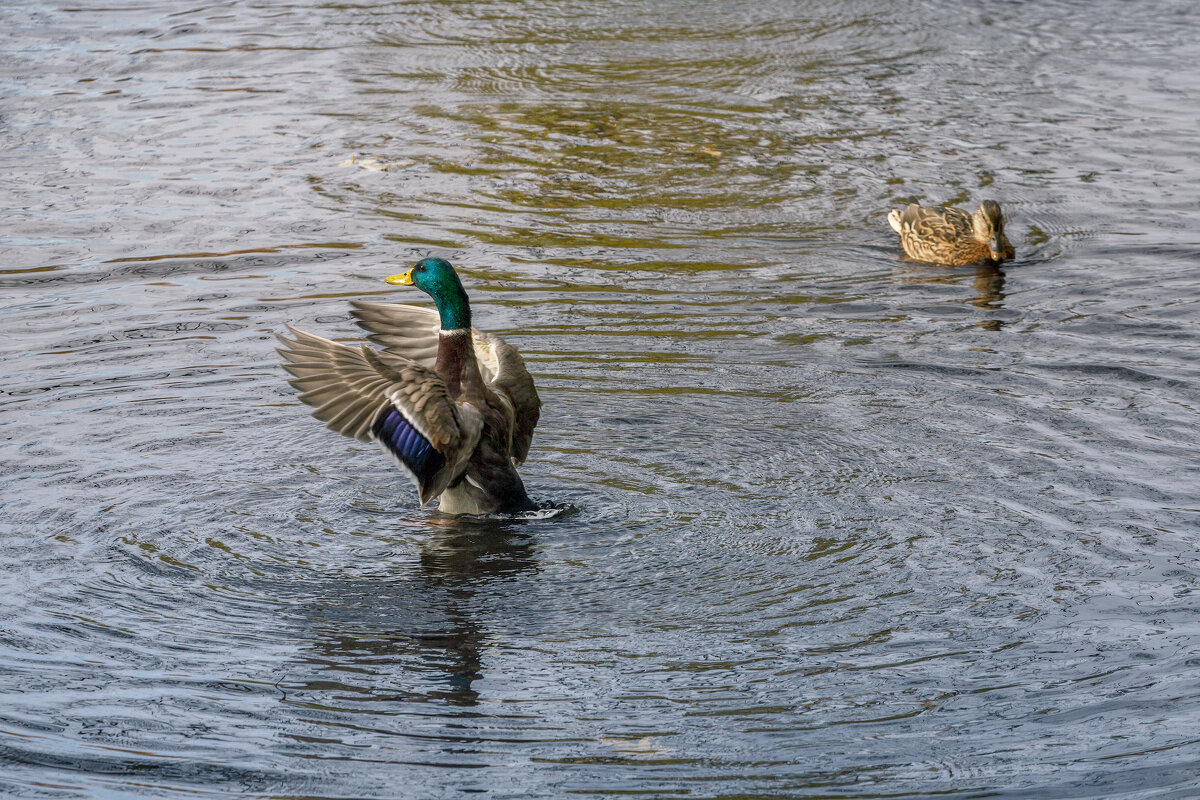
[278,326,482,506]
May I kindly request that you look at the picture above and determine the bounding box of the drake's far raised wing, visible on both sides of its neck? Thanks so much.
[350,301,541,464]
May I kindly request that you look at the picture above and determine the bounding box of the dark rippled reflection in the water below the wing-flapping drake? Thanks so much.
[290,518,536,712]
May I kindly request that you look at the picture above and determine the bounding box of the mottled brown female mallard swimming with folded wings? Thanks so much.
[888,200,1015,266]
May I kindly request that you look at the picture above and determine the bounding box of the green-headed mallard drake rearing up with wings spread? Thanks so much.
[280,258,541,513]
